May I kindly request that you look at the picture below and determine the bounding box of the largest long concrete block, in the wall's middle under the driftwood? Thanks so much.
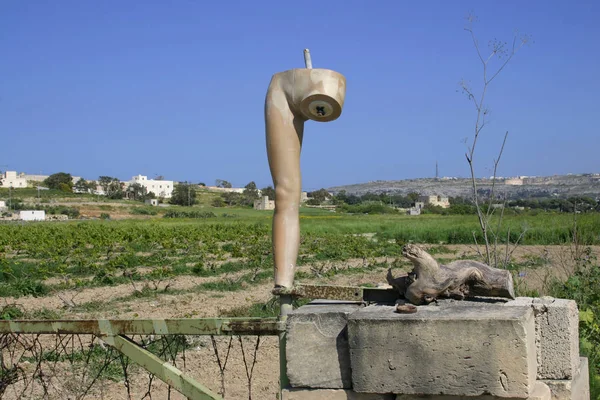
[348,302,537,399]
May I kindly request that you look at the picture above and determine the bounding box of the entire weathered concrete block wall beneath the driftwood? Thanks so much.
[283,298,590,400]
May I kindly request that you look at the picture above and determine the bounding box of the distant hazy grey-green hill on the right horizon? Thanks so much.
[327,174,600,199]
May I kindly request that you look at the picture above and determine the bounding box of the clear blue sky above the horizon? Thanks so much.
[0,0,600,190]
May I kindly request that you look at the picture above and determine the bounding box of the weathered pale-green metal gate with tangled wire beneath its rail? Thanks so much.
[0,318,284,400]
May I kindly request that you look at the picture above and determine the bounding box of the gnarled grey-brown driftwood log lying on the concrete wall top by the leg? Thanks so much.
[387,244,515,305]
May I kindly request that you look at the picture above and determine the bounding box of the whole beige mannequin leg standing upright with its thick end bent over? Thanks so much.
[265,69,346,288]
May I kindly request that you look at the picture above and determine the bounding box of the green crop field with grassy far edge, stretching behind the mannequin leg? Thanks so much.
[0,207,600,295]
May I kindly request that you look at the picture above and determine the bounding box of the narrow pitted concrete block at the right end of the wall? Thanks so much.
[506,297,579,380]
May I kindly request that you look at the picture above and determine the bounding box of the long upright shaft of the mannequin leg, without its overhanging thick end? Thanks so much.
[265,84,304,287]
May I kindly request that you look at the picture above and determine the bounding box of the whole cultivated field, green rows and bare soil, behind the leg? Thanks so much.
[0,205,600,399]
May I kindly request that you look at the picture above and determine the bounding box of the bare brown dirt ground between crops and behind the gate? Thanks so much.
[2,245,600,400]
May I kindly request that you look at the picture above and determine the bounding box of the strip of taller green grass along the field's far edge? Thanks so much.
[77,206,600,245]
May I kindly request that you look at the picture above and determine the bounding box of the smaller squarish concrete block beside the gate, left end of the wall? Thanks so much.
[286,303,360,389]
